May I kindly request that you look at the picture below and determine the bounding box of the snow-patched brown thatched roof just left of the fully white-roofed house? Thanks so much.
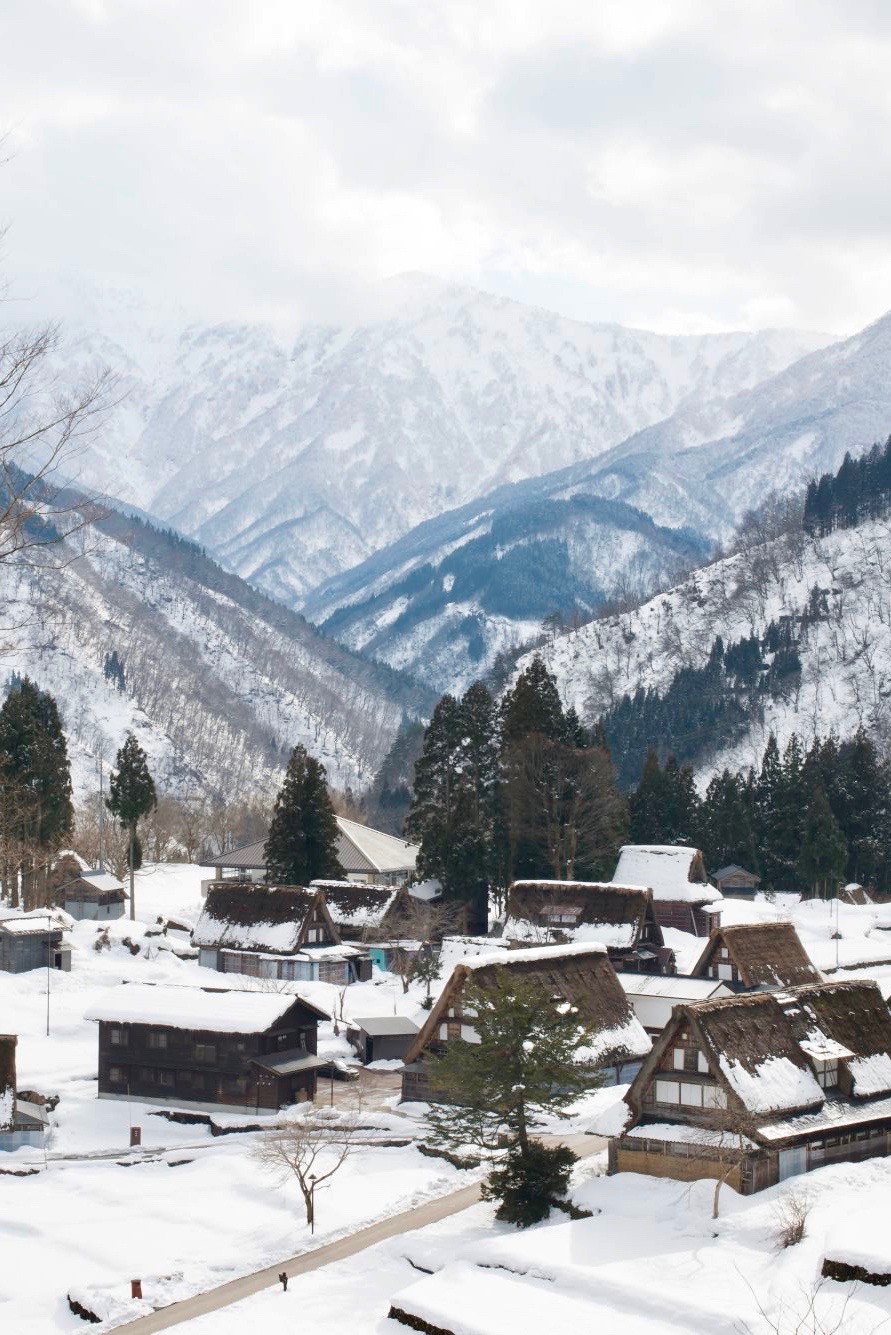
[504,881,663,948]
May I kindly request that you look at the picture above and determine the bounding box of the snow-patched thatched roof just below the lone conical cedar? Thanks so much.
[192,881,341,955]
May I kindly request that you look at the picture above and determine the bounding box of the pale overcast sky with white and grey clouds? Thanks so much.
[0,0,891,332]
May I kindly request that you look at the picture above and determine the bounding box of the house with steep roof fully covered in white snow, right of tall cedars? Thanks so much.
[613,844,721,936]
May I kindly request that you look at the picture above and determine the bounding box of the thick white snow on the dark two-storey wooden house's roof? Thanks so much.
[84,983,322,1033]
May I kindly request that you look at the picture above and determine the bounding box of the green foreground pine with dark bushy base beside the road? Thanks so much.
[427,971,592,1224]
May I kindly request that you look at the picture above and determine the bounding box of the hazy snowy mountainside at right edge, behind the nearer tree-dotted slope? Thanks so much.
[573,312,891,534]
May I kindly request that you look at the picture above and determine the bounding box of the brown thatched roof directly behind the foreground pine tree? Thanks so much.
[405,944,651,1065]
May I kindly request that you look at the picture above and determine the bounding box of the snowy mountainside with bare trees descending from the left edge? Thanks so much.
[0,514,431,800]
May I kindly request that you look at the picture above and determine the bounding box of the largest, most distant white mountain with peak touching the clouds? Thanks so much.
[57,275,827,605]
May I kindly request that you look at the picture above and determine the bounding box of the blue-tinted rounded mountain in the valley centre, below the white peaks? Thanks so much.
[305,475,707,690]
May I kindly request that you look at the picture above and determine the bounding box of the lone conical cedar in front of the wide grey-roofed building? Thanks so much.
[263,745,343,885]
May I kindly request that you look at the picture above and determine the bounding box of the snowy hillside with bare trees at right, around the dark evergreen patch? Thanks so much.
[518,519,891,780]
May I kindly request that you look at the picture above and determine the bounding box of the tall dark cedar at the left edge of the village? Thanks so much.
[0,677,73,908]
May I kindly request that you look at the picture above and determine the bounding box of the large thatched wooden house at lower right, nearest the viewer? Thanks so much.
[609,979,891,1193]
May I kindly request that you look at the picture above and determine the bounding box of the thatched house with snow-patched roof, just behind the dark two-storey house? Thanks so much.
[192,881,371,985]
